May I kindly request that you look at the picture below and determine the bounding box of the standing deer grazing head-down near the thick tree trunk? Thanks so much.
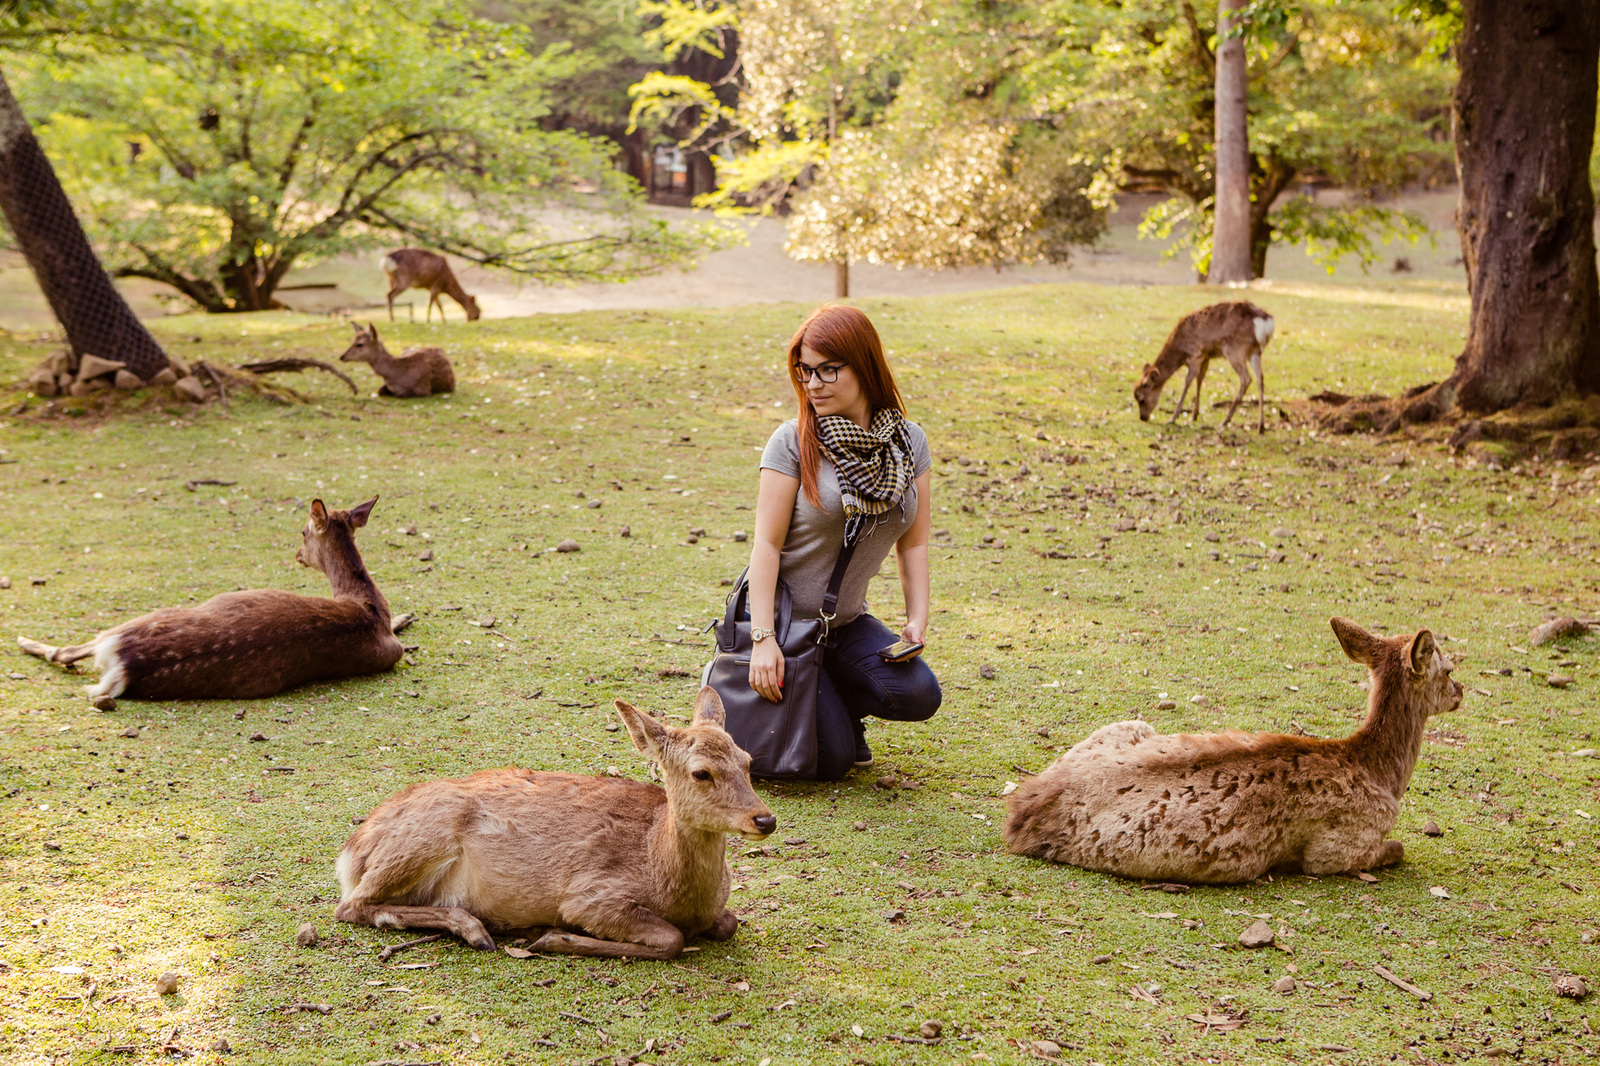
[1133,301,1274,432]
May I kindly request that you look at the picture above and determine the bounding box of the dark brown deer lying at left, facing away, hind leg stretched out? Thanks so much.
[18,496,402,699]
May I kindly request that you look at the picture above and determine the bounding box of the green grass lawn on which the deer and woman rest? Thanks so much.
[0,282,1600,1066]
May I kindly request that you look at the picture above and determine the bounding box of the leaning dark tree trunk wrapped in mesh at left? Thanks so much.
[0,72,166,381]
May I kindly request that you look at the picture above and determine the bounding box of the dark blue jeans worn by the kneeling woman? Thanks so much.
[816,615,944,781]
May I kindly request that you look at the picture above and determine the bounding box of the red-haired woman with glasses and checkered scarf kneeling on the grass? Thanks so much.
[749,306,942,781]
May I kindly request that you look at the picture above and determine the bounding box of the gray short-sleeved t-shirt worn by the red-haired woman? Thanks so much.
[762,418,933,626]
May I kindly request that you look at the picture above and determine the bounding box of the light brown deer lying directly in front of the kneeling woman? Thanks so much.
[333,688,778,959]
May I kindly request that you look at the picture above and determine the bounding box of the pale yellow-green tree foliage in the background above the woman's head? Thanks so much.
[632,0,1106,267]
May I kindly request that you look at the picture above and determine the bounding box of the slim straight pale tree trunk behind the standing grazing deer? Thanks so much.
[1206,0,1250,285]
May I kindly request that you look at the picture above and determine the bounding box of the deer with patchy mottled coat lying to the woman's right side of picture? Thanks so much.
[1005,618,1461,884]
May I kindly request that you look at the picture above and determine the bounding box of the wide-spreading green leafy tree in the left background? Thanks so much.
[11,0,729,311]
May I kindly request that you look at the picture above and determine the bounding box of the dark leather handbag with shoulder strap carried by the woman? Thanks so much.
[701,546,856,778]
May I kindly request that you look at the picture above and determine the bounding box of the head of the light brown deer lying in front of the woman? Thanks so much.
[616,688,778,840]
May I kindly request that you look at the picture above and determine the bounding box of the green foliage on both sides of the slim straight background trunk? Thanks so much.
[1021,0,1453,274]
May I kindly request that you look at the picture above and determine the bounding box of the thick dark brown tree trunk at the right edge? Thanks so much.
[1433,0,1600,416]
